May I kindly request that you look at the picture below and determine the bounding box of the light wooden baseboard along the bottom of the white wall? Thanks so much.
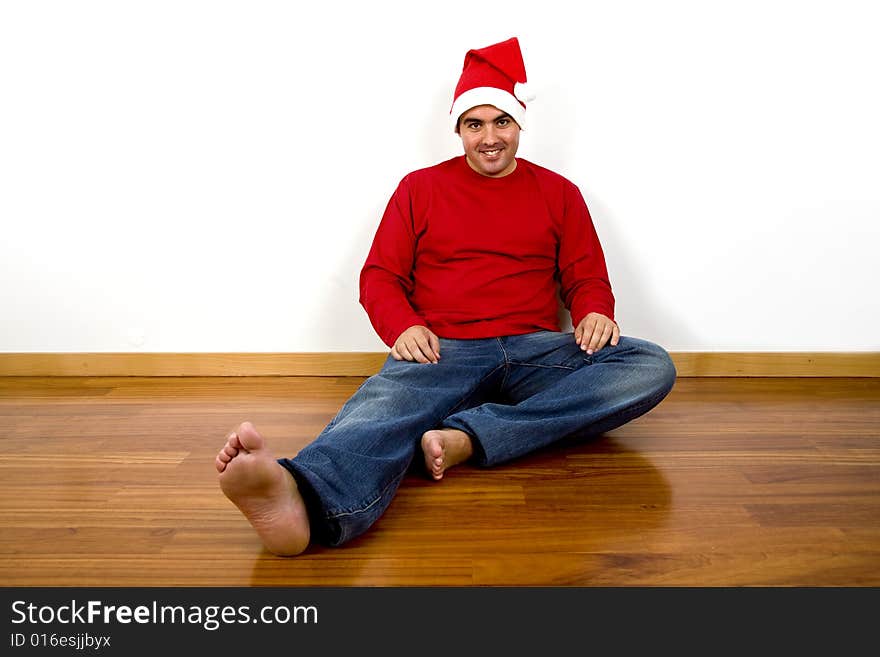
[0,352,880,377]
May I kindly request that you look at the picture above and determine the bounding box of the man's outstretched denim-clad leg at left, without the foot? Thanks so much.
[280,340,503,545]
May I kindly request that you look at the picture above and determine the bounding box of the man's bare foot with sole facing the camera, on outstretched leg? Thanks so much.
[214,422,310,556]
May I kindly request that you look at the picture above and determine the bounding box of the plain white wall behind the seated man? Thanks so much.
[0,0,880,352]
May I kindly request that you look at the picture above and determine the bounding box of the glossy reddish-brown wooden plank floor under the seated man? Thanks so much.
[0,377,880,586]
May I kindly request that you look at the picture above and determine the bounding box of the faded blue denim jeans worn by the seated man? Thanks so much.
[279,331,676,545]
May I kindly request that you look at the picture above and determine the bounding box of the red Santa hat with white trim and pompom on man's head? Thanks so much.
[449,37,534,132]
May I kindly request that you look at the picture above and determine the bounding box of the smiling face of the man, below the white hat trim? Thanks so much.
[458,105,519,178]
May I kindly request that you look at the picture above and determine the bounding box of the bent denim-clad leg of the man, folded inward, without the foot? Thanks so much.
[443,332,675,466]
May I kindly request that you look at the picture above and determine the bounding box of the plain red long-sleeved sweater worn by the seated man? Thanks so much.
[360,155,614,347]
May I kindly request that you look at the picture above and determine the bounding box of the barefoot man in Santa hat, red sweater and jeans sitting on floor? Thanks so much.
[216,38,675,555]
